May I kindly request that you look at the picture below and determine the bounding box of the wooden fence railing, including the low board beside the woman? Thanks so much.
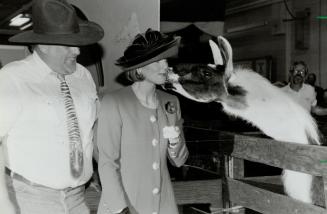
[174,129,327,214]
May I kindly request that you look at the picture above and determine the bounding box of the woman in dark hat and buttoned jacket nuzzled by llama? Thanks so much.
[98,29,188,214]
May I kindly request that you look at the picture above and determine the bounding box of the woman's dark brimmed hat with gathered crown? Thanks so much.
[116,28,180,71]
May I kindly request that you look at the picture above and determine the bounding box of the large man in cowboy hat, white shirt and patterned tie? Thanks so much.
[0,0,104,214]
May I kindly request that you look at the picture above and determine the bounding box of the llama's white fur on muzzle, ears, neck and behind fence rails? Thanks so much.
[173,37,319,203]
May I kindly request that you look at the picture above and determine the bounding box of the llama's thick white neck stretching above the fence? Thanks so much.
[222,70,319,144]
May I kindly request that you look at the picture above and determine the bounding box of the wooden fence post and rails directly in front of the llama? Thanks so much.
[219,133,327,214]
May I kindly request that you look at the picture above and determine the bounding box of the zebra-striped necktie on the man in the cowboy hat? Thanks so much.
[57,74,83,178]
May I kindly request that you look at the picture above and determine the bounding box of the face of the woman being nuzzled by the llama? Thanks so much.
[142,59,168,85]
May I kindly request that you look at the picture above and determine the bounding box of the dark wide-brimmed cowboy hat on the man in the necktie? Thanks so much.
[9,0,104,46]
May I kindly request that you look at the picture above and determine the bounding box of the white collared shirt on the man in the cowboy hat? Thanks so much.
[0,52,98,189]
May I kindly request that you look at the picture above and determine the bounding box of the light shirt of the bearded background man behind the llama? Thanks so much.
[281,84,317,112]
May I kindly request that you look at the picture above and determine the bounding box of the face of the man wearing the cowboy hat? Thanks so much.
[42,45,80,75]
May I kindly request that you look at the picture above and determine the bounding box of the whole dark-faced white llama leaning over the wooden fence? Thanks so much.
[167,36,320,203]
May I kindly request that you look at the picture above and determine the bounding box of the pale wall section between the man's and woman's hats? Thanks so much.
[70,0,160,91]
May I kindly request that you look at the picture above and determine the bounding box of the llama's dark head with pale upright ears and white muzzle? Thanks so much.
[168,37,237,102]
